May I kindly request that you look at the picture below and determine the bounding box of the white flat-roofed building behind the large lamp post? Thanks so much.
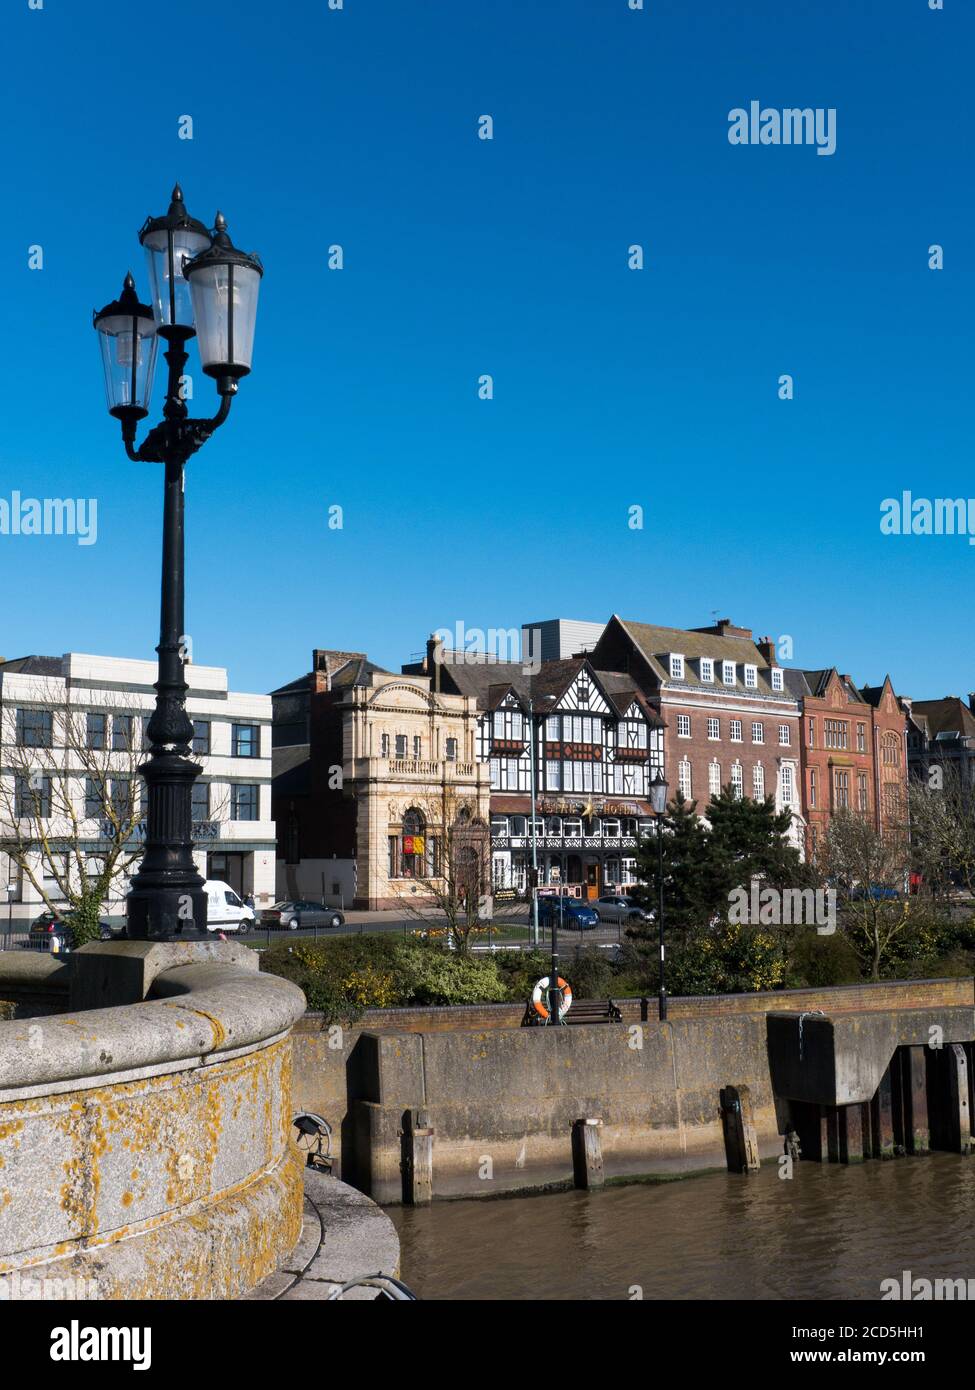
[0,652,275,919]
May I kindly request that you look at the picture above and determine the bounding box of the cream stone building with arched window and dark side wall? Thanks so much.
[271,649,490,909]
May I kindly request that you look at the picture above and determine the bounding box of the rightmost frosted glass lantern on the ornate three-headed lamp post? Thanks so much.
[185,213,264,389]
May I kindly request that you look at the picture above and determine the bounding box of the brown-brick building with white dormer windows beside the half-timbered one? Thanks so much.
[590,614,805,851]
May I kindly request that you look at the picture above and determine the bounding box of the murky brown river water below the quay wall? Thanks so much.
[389,1154,975,1300]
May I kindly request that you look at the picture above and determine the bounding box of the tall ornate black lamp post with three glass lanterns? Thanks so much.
[95,185,263,941]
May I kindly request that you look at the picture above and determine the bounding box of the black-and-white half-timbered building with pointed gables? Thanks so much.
[405,638,663,898]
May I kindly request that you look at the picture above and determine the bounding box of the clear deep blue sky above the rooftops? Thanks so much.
[0,0,975,698]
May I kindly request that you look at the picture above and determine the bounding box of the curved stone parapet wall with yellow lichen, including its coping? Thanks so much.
[0,942,305,1298]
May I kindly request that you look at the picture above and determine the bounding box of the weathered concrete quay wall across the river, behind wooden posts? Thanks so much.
[295,979,975,1202]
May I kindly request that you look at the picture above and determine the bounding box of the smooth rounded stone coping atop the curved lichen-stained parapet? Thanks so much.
[0,958,305,1099]
